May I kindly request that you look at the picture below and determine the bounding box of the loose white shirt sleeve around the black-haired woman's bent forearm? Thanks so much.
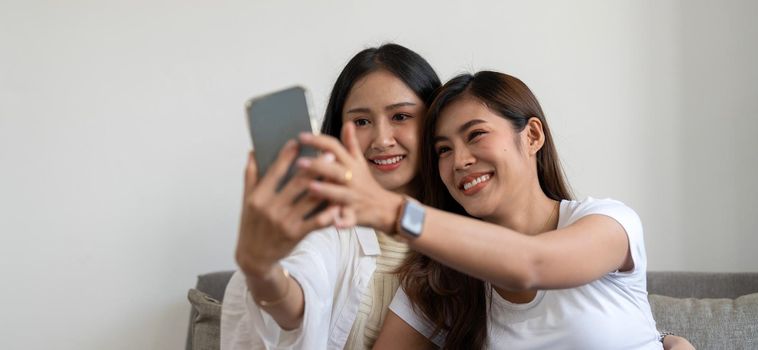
[221,229,340,350]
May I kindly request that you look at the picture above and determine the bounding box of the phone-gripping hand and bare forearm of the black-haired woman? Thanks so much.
[235,141,337,329]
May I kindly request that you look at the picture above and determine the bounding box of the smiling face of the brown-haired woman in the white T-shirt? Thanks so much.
[434,96,537,220]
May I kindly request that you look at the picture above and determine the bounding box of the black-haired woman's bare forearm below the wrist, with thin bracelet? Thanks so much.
[246,266,305,330]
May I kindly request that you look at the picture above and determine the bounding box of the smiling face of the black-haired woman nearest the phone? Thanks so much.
[342,70,426,193]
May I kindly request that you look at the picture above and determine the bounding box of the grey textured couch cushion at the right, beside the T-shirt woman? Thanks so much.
[649,293,758,349]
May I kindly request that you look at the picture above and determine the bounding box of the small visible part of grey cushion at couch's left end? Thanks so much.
[187,289,221,350]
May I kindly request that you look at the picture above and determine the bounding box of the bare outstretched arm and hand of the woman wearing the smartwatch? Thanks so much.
[299,123,633,290]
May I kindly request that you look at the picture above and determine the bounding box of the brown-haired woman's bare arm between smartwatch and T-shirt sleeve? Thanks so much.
[386,198,633,291]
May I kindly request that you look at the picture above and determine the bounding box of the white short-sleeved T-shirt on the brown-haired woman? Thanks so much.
[390,198,663,350]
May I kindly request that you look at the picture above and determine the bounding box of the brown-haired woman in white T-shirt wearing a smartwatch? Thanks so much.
[301,72,689,349]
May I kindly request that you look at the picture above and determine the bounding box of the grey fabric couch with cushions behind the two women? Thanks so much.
[187,271,758,350]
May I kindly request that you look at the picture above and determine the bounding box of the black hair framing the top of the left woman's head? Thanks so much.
[321,43,442,138]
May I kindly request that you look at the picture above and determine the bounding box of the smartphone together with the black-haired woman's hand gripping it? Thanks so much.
[236,87,340,278]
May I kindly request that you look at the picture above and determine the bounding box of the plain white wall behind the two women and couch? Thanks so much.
[0,0,758,349]
